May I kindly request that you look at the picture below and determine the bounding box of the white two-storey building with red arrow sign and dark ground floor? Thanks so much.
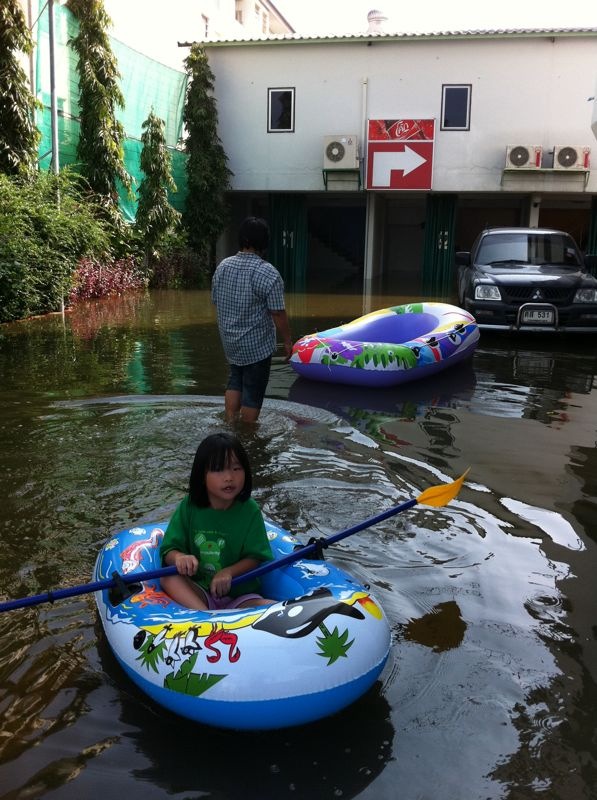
[199,21,597,293]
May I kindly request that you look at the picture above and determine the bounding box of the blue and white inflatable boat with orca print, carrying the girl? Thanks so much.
[94,521,390,730]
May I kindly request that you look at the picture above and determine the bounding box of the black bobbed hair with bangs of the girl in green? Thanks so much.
[189,433,253,508]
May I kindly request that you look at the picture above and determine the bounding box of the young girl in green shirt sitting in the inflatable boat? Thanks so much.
[160,433,273,610]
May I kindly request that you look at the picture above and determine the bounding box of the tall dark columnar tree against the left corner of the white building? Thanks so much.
[183,44,232,267]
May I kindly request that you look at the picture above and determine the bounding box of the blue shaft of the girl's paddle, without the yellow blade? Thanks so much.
[0,500,417,612]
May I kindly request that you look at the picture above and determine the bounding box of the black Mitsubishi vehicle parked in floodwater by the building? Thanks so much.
[456,228,597,333]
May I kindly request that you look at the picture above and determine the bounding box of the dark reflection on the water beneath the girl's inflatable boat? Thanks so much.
[95,632,394,800]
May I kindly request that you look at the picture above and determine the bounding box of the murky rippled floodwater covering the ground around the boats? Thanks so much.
[0,292,597,800]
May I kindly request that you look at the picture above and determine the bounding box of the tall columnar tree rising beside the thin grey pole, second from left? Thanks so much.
[67,0,131,216]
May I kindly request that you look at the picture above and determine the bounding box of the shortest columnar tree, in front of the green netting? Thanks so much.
[136,109,180,260]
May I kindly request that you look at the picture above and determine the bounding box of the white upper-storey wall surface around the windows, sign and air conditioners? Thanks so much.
[208,33,597,193]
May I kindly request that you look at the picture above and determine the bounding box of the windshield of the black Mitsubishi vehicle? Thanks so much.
[475,232,582,267]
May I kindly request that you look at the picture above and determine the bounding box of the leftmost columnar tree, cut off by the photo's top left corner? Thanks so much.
[0,0,40,175]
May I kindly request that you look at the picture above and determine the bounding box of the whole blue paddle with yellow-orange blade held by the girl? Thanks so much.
[0,469,469,612]
